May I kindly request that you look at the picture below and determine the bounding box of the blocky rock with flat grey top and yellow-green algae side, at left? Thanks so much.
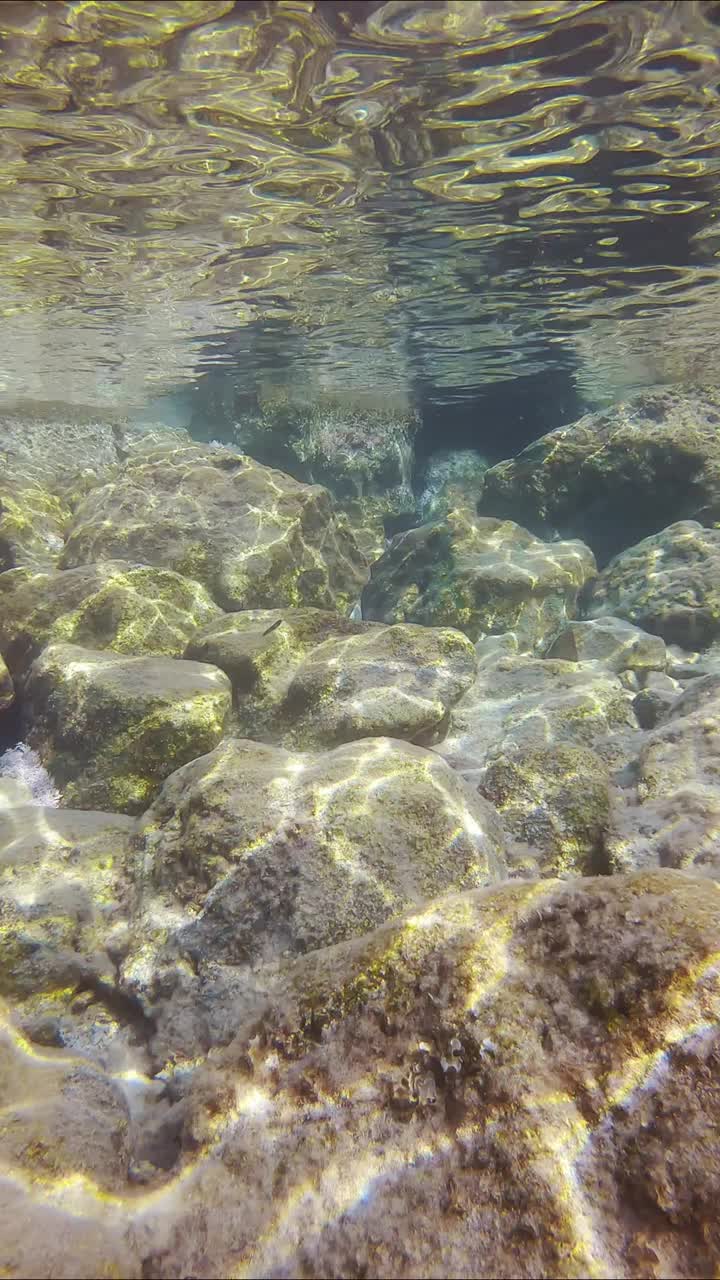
[26,644,232,814]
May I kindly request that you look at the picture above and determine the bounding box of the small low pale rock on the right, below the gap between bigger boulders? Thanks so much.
[546,614,667,672]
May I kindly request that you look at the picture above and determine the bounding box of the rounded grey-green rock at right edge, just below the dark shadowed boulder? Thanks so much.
[588,520,720,649]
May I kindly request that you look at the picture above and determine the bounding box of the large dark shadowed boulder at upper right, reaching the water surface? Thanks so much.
[480,388,720,564]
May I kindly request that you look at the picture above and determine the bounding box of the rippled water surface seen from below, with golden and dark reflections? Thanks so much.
[0,0,720,402]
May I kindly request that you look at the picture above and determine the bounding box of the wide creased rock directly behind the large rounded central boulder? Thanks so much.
[186,609,475,749]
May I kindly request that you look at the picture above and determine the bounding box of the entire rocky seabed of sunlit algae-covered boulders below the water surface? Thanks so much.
[0,388,720,1280]
